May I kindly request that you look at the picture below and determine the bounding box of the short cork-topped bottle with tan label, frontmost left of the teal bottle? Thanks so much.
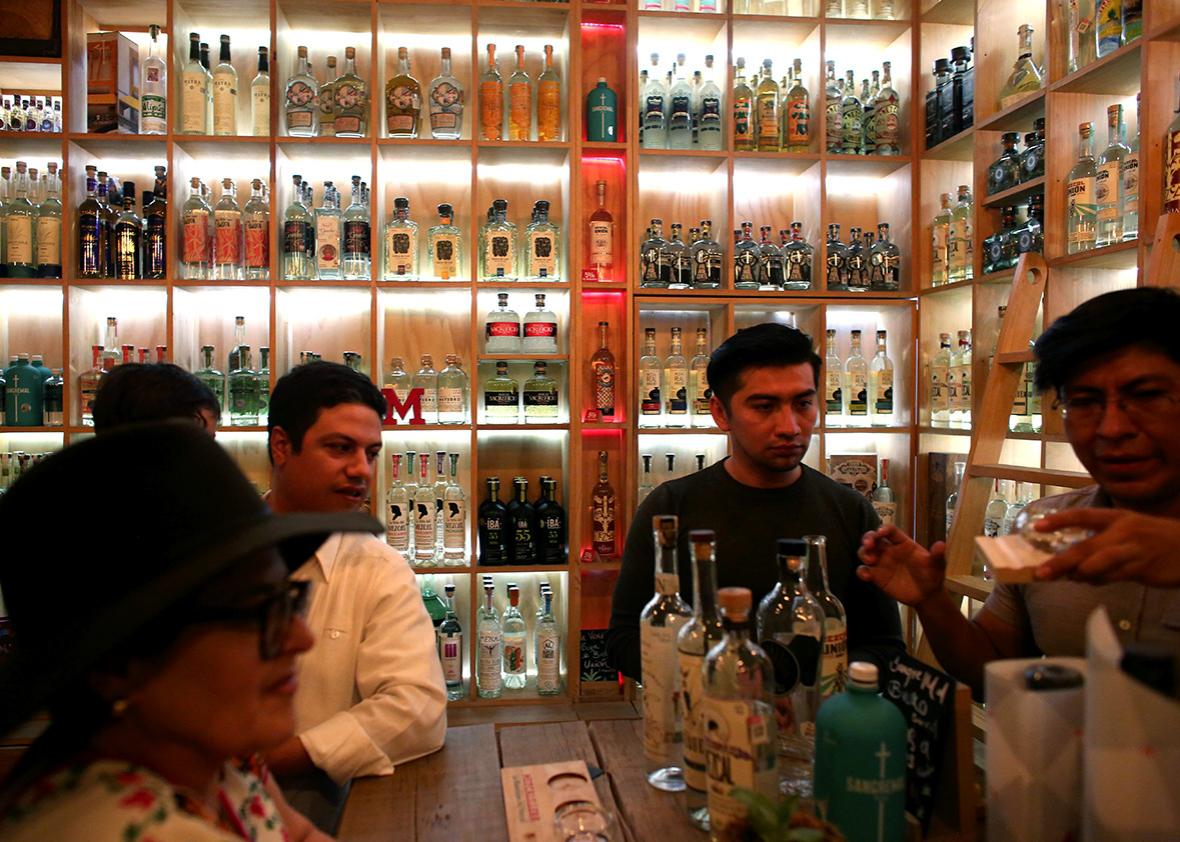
[702,587,779,840]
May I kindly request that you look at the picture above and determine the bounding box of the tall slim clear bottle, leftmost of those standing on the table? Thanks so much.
[640,514,693,792]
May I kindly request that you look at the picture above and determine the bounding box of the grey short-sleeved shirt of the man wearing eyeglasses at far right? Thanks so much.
[984,486,1180,657]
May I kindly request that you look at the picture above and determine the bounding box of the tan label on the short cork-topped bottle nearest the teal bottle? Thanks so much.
[702,696,779,825]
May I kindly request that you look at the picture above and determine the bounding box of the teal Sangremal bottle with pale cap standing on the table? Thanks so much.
[815,660,906,842]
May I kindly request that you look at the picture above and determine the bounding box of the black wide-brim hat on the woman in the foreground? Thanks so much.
[0,421,381,734]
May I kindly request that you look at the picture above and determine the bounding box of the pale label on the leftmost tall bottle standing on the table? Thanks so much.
[640,616,688,763]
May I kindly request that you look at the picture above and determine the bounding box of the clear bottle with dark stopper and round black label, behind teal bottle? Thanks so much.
[758,538,825,791]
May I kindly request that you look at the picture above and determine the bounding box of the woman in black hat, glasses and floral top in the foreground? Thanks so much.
[0,423,379,842]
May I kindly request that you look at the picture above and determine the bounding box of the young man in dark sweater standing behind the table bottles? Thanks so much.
[607,324,904,679]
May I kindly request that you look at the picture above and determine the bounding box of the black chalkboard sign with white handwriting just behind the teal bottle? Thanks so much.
[881,654,955,834]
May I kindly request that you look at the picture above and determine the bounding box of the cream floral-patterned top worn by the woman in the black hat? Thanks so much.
[0,759,288,842]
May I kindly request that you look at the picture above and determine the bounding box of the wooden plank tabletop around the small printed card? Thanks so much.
[337,719,706,842]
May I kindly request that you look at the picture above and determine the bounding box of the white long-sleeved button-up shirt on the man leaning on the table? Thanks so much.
[291,533,446,783]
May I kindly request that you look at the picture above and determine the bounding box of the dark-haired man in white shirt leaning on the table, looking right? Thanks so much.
[267,362,446,831]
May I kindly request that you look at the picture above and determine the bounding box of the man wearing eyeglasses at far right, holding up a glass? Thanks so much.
[857,288,1180,696]
